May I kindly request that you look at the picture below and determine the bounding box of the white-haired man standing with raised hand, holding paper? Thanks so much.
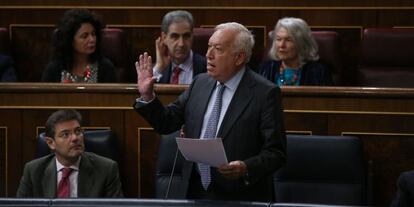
[134,22,286,201]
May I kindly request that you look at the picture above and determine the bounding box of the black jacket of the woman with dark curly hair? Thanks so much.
[42,58,117,83]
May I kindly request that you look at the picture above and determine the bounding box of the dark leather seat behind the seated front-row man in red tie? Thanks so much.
[36,130,119,163]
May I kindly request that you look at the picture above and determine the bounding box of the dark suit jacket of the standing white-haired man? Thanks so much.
[134,69,286,201]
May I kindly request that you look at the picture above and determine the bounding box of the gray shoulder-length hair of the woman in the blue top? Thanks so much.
[269,17,319,65]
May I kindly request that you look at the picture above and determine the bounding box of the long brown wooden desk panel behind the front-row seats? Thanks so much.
[0,83,414,206]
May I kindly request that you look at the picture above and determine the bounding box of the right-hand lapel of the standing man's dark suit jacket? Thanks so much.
[217,68,255,139]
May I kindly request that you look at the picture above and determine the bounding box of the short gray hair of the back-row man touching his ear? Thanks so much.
[161,10,194,34]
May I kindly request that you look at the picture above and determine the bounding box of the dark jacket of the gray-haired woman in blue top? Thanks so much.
[259,60,333,86]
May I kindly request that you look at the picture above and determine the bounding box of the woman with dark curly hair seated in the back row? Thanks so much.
[42,9,116,83]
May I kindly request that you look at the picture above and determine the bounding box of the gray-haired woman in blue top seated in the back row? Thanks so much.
[259,17,333,86]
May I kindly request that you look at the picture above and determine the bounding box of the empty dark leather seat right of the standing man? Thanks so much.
[274,135,368,205]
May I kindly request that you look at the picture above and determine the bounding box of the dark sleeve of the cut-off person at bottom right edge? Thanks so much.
[391,170,414,207]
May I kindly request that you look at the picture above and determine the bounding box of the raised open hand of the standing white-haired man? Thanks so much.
[135,52,157,102]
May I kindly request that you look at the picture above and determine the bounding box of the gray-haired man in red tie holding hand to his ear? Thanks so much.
[153,10,206,84]
